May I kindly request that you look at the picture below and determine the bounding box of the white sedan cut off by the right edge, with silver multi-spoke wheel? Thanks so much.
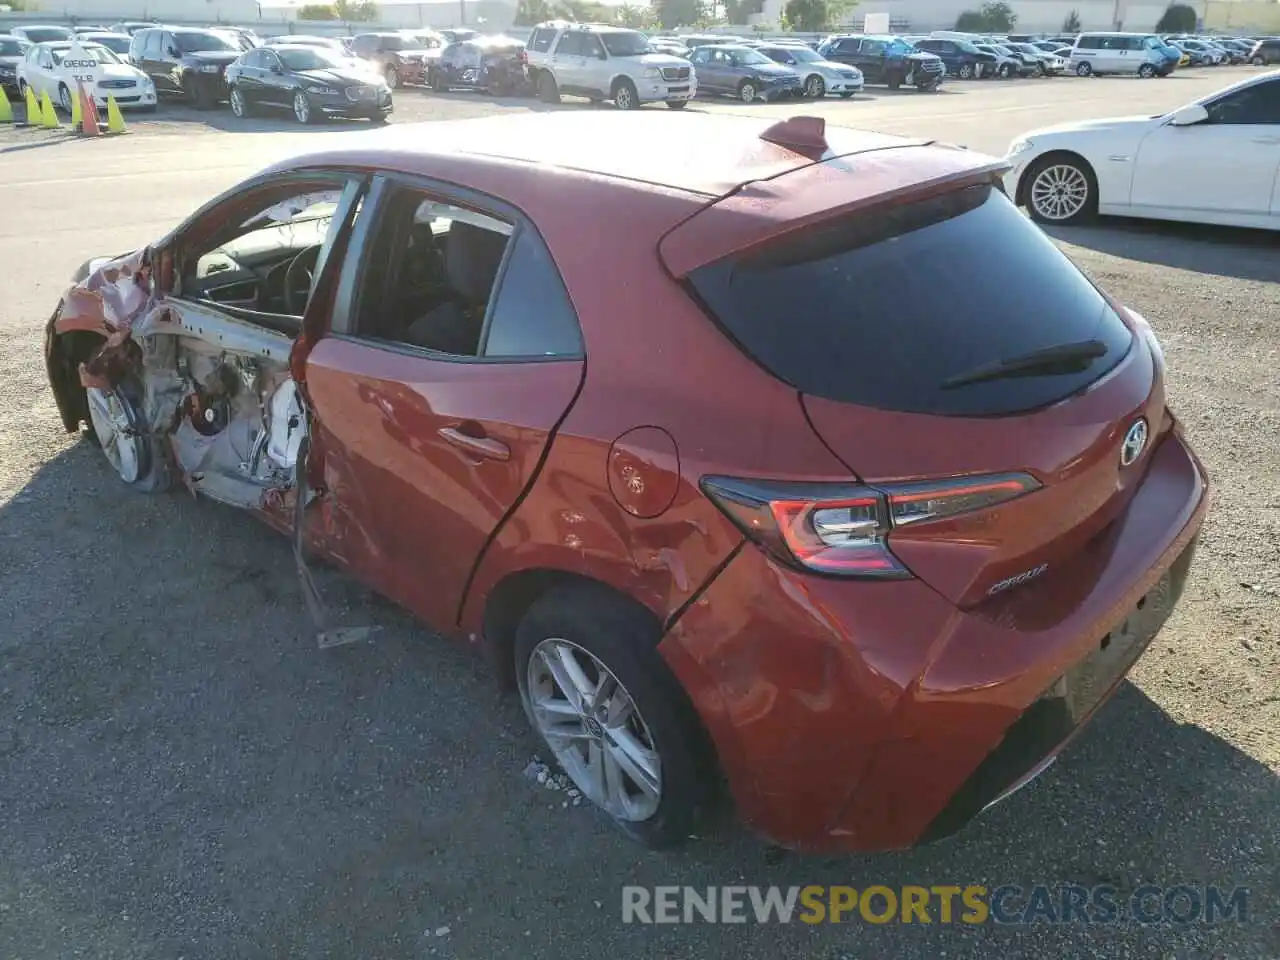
[1005,70,1280,230]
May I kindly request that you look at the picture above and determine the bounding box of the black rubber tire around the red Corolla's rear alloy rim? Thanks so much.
[515,585,714,849]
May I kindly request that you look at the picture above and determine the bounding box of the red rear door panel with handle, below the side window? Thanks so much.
[306,338,584,628]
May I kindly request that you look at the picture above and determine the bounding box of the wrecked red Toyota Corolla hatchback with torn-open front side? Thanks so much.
[40,113,1207,850]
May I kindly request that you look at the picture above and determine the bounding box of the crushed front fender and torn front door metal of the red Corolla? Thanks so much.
[46,250,306,509]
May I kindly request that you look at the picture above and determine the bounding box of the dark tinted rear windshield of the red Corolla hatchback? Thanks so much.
[689,184,1132,416]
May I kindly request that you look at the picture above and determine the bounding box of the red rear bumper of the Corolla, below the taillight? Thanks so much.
[659,433,1207,851]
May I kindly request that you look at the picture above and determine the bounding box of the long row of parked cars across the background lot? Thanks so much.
[0,20,1280,123]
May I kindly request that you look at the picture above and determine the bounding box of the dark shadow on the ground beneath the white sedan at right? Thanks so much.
[1044,216,1280,283]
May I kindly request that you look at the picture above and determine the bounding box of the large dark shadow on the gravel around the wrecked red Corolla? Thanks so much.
[0,437,1280,960]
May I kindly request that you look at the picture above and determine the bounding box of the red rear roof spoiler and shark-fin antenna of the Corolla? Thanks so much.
[658,134,1009,279]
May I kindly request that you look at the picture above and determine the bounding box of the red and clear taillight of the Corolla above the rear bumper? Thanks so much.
[701,474,1039,579]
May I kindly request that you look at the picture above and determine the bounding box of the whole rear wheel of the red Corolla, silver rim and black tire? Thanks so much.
[515,586,713,847]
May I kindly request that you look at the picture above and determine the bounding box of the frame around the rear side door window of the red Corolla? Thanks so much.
[321,170,586,365]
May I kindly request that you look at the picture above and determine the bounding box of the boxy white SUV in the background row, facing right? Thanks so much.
[527,20,698,110]
